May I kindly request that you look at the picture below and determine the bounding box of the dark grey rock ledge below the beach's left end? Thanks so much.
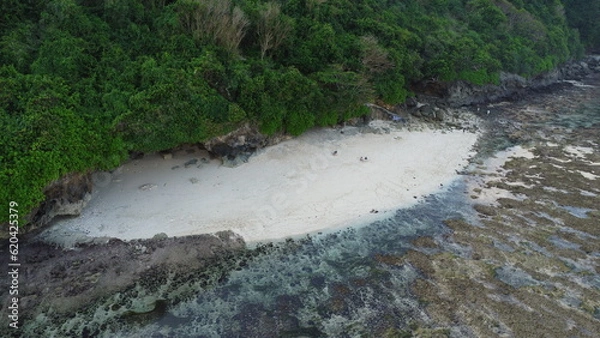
[0,231,246,337]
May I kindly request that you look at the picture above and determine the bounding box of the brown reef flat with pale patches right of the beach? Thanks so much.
[402,70,600,337]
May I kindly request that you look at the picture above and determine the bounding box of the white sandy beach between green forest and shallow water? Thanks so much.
[41,121,478,245]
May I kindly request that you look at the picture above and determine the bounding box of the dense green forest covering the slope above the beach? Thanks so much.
[0,0,599,223]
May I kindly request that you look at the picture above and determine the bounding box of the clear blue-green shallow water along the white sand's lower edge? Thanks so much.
[108,184,476,337]
